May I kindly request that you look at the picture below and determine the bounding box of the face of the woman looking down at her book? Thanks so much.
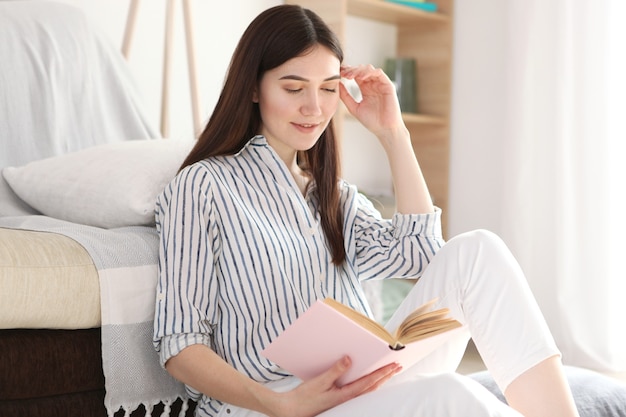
[254,45,340,162]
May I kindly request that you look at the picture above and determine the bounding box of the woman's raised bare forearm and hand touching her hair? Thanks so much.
[339,65,434,214]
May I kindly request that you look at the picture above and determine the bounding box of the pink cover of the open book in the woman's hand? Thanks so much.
[261,300,463,385]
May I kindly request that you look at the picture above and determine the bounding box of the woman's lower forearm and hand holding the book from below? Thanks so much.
[165,345,400,417]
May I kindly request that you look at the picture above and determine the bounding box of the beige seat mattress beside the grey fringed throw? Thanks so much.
[0,228,101,329]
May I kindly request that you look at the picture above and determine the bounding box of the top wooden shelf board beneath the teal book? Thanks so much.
[348,0,450,25]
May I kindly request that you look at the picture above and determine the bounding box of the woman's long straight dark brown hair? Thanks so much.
[181,5,346,265]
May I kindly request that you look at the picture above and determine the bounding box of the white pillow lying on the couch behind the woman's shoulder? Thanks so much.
[2,139,194,228]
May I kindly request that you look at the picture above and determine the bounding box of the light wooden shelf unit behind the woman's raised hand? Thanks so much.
[286,0,454,233]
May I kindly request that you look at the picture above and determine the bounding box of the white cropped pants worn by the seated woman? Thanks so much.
[213,230,560,417]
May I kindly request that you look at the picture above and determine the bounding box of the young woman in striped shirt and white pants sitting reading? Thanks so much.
[155,6,577,417]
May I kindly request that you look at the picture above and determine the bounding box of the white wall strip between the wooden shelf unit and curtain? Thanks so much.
[448,0,507,236]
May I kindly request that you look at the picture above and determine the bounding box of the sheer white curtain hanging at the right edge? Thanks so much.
[494,0,626,372]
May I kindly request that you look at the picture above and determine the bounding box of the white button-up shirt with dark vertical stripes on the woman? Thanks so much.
[154,136,443,416]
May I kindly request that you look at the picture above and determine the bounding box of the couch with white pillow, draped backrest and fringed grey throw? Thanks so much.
[0,0,626,417]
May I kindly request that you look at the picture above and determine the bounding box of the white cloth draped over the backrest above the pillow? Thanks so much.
[0,1,160,168]
